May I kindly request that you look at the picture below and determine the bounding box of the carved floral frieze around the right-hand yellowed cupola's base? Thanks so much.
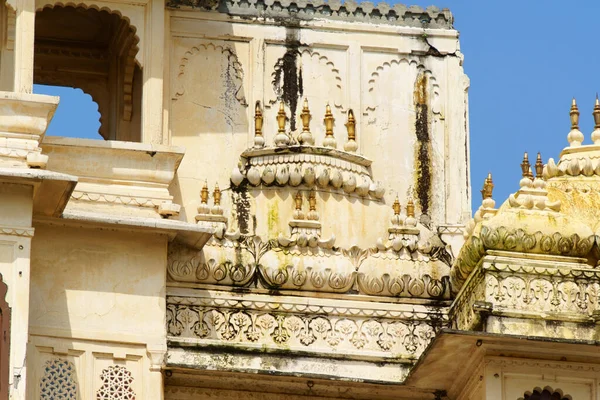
[450,259,600,332]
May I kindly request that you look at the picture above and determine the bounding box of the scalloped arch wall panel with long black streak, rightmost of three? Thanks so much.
[361,53,445,222]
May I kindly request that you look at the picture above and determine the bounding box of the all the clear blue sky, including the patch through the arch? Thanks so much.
[35,0,600,209]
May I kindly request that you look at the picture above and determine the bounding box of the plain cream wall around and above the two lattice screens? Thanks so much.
[28,224,167,399]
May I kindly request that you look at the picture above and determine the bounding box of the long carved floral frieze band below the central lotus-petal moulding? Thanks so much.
[167,296,446,359]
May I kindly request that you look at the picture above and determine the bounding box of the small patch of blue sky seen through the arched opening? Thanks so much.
[33,85,104,140]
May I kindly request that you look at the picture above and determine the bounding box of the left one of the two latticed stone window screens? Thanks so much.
[40,358,79,400]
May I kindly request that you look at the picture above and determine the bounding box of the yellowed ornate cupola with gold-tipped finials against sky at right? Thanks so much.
[450,99,600,340]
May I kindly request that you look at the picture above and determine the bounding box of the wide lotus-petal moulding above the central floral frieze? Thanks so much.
[167,233,450,299]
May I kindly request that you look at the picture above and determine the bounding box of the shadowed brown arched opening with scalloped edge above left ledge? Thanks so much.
[34,6,142,142]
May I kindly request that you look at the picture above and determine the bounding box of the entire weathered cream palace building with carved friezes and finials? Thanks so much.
[0,0,600,400]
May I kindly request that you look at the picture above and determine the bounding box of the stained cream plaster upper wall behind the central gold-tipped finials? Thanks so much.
[165,10,470,247]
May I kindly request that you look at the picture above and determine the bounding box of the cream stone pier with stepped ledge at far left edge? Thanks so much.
[0,92,76,400]
